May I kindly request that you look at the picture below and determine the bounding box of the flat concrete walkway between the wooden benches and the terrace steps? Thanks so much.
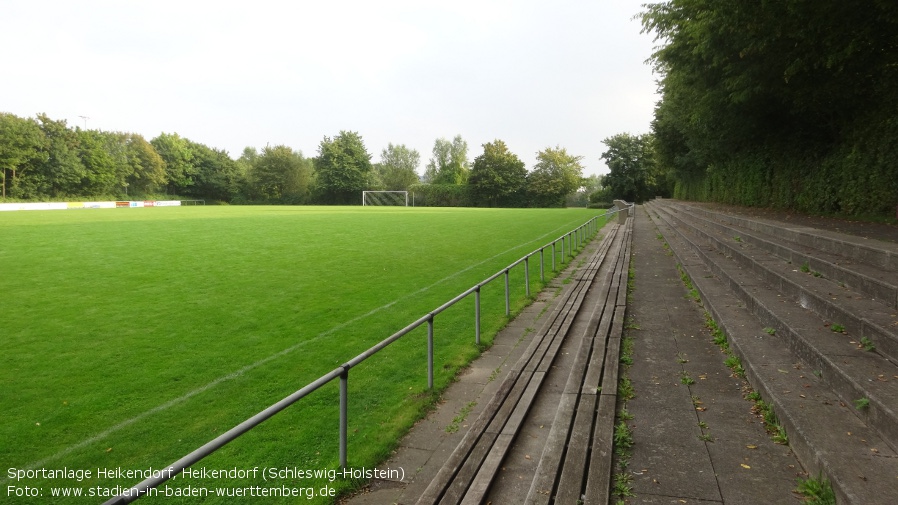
[625,206,803,504]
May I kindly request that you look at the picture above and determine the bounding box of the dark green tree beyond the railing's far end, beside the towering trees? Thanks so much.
[602,133,664,202]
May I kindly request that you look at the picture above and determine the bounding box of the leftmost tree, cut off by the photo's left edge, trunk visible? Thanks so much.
[0,112,46,198]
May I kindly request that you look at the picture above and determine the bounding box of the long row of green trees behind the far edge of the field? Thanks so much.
[0,113,600,207]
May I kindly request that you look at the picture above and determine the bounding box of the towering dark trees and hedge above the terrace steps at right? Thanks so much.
[641,0,898,216]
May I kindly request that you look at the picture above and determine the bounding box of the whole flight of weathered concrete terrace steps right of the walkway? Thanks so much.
[646,201,898,504]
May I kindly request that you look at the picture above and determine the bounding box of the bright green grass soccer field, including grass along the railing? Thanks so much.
[0,207,601,503]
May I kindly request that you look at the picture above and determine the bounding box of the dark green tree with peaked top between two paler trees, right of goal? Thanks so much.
[468,140,527,207]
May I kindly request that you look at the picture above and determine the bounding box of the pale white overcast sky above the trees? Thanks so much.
[0,0,657,175]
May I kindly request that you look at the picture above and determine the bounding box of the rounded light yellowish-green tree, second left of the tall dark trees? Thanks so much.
[527,146,583,207]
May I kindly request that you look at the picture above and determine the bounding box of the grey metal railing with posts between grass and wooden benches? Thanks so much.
[104,209,623,505]
